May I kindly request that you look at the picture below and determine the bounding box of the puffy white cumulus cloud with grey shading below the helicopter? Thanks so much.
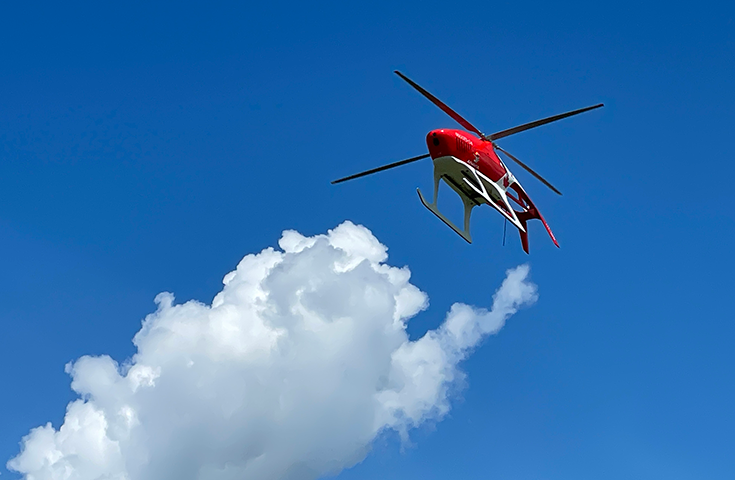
[8,222,536,480]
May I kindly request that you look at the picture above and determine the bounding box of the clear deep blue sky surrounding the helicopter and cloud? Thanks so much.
[0,2,735,479]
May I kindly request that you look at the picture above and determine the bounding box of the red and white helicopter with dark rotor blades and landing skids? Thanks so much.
[332,70,603,253]
